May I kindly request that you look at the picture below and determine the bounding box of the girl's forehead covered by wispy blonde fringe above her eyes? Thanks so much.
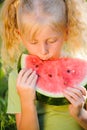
[20,13,65,40]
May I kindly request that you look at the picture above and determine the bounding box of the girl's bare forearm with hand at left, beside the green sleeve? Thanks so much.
[16,69,39,130]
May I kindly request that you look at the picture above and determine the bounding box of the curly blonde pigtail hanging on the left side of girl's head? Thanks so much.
[1,0,25,69]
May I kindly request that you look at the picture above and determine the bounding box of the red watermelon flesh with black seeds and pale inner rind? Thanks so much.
[21,54,87,98]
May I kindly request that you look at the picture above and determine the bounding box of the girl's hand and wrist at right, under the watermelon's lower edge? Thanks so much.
[64,87,87,117]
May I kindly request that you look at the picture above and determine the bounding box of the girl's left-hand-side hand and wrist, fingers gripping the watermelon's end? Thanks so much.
[17,69,38,101]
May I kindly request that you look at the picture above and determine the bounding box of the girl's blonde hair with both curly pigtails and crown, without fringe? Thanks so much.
[1,0,87,70]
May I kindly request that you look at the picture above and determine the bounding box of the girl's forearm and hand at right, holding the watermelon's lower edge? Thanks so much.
[64,87,87,130]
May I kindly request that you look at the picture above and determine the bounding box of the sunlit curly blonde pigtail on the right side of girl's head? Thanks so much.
[65,0,87,60]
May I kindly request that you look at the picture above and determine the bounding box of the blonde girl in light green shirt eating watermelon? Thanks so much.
[2,0,87,130]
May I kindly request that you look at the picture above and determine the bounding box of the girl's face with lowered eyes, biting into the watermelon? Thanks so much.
[24,26,64,60]
